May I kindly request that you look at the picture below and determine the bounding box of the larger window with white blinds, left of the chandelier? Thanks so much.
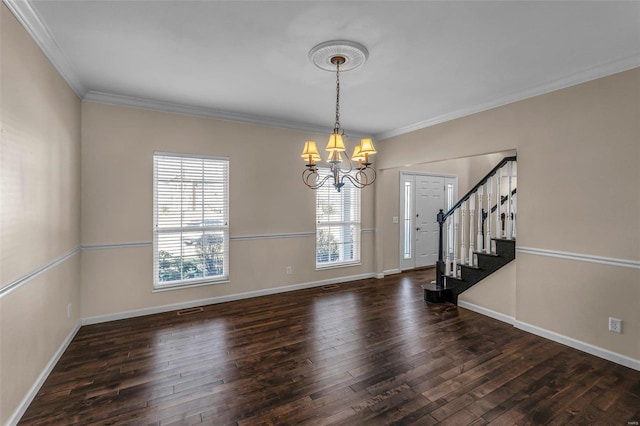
[153,153,229,289]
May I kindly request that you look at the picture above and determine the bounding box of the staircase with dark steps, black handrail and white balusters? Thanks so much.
[422,156,517,304]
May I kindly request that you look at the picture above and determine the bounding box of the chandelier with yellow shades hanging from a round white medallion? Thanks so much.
[301,41,376,192]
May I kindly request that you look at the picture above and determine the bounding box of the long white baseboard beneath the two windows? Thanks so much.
[82,273,376,325]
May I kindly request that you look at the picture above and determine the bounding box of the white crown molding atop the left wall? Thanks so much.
[2,0,87,99]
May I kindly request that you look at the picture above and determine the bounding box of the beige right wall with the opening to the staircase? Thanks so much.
[377,69,640,360]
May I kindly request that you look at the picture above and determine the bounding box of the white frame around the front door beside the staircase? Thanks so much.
[398,171,458,271]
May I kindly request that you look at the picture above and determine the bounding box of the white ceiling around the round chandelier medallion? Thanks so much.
[4,0,640,139]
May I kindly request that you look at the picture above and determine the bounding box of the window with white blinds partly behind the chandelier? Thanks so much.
[316,168,360,268]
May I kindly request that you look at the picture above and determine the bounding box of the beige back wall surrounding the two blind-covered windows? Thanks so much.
[82,102,375,318]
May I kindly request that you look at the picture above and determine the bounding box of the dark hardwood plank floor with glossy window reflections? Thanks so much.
[22,270,640,425]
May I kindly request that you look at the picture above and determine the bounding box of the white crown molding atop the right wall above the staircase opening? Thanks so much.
[374,52,640,141]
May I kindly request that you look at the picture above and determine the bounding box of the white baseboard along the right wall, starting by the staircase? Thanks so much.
[458,301,640,371]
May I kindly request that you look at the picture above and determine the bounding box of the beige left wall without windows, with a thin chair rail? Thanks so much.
[0,4,80,424]
